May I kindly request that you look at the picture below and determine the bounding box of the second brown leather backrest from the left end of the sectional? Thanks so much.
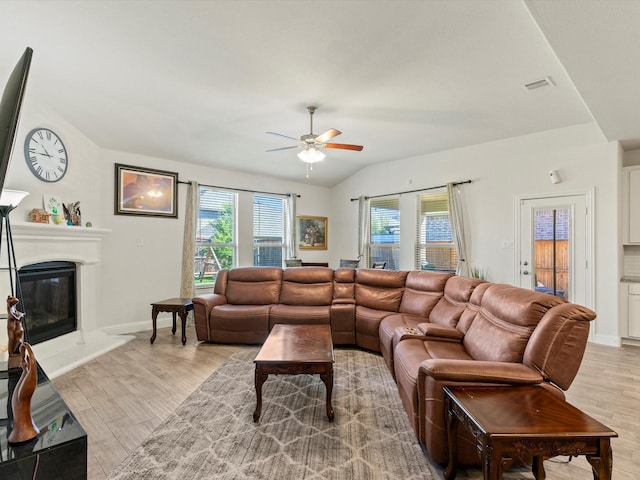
[279,267,333,306]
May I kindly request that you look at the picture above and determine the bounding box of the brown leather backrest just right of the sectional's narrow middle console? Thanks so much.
[356,269,408,312]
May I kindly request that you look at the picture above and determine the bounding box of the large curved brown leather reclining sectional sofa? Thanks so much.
[193,267,596,464]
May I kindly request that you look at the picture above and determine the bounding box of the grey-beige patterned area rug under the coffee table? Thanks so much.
[108,348,441,480]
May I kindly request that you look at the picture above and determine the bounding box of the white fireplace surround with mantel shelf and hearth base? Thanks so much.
[0,222,133,378]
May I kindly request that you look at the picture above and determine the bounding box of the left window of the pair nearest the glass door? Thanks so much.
[368,196,400,270]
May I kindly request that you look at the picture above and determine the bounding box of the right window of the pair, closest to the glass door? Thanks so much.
[416,192,458,272]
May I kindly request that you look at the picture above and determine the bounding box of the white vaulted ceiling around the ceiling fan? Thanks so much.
[0,0,640,186]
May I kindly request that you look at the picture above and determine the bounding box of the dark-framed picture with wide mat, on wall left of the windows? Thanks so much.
[114,163,178,218]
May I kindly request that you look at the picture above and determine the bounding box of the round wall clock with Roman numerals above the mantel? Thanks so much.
[24,128,69,182]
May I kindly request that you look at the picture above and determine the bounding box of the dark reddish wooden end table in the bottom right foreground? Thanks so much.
[444,385,618,480]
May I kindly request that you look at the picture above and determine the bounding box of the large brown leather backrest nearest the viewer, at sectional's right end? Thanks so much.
[463,284,564,363]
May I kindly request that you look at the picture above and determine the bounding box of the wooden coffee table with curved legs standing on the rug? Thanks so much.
[253,324,334,422]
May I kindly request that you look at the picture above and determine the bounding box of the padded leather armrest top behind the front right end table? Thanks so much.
[418,358,543,384]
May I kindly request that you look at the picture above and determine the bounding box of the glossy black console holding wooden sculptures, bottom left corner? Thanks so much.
[0,362,87,480]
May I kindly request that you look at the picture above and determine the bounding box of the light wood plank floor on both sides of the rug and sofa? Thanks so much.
[54,327,640,480]
